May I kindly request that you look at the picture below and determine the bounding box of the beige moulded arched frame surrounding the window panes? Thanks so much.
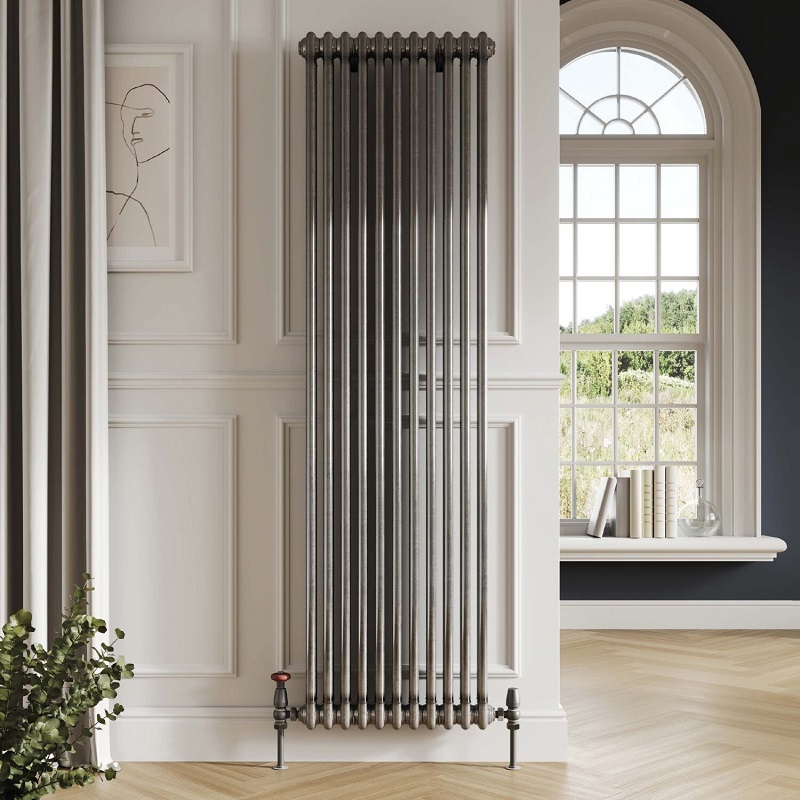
[561,0,761,536]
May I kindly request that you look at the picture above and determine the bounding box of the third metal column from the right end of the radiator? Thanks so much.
[442,33,455,730]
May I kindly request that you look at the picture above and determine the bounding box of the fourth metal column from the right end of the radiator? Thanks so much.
[425,33,438,730]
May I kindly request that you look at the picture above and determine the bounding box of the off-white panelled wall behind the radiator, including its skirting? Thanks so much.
[106,0,566,761]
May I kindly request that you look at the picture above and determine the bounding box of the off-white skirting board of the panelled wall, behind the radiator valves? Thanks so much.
[111,706,567,765]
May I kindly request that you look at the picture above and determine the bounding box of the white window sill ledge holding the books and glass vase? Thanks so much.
[559,535,786,561]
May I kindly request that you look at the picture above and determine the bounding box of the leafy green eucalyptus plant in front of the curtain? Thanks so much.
[0,573,133,800]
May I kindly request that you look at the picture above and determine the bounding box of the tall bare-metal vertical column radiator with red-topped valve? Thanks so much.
[273,33,519,766]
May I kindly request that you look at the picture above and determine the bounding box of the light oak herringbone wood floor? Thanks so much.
[63,631,800,800]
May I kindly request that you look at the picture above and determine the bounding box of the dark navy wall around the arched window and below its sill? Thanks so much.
[561,0,800,600]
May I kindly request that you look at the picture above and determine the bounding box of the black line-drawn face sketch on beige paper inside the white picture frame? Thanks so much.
[106,77,171,247]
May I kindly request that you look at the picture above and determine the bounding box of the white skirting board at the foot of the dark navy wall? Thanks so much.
[561,600,800,630]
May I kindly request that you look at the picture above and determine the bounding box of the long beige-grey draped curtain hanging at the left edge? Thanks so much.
[0,0,110,763]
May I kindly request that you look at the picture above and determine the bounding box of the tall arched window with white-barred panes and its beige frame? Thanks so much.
[559,0,759,536]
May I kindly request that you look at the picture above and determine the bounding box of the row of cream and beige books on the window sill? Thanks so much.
[587,466,678,539]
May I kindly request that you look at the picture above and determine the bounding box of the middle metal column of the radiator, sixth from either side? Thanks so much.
[391,33,403,729]
